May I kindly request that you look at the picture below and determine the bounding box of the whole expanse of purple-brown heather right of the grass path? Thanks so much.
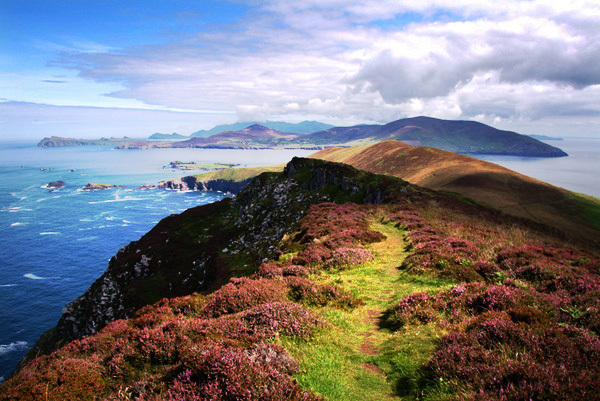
[383,205,600,400]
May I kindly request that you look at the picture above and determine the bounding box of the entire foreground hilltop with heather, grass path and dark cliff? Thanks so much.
[0,158,600,401]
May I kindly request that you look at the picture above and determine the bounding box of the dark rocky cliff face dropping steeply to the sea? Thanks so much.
[15,158,421,366]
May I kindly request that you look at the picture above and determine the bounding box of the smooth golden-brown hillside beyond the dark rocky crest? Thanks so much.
[311,141,600,243]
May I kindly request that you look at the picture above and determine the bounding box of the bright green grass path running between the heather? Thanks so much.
[282,224,450,401]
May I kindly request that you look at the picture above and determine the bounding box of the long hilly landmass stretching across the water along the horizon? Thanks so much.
[38,117,568,157]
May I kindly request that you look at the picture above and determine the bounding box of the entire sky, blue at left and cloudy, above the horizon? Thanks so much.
[0,0,600,140]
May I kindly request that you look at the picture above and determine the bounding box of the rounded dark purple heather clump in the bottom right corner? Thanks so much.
[426,314,600,400]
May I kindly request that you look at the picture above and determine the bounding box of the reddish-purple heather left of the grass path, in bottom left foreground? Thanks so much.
[0,290,324,400]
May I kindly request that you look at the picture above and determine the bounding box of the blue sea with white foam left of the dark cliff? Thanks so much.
[0,142,312,381]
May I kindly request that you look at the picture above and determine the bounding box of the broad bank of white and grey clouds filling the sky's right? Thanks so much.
[43,0,600,128]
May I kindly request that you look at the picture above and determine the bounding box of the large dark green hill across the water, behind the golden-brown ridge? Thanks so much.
[299,117,567,157]
